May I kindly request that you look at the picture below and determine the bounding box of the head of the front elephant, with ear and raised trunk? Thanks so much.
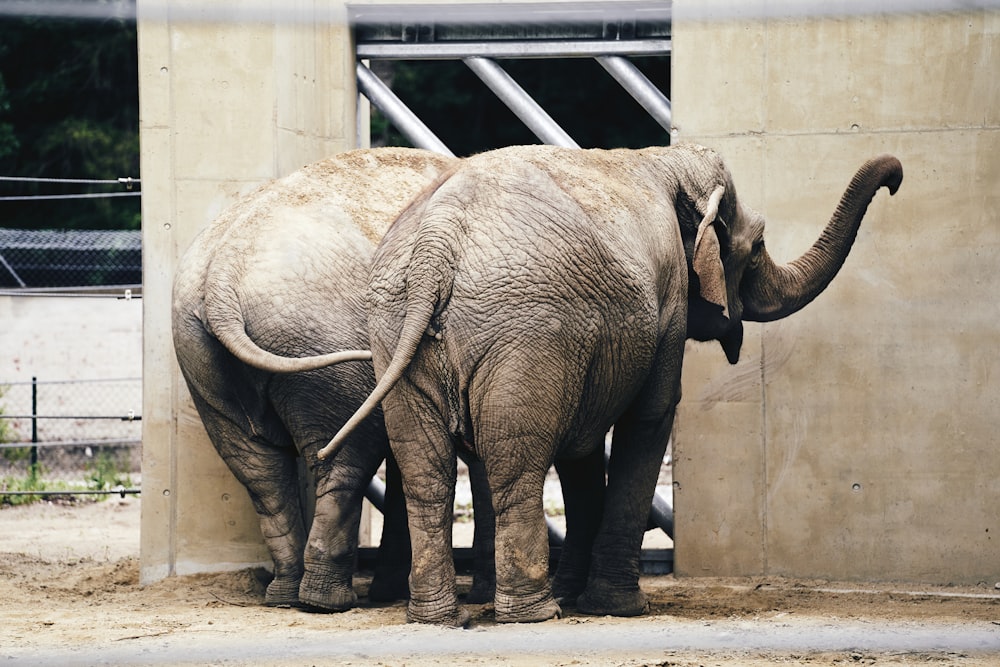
[676,146,903,364]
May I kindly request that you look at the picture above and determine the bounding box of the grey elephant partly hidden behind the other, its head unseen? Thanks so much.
[173,148,468,610]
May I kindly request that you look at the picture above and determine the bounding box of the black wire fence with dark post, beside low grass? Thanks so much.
[0,378,142,502]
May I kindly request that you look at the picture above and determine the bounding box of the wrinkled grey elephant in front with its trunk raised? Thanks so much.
[319,143,902,626]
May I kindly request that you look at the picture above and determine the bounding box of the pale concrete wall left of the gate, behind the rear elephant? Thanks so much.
[138,0,357,582]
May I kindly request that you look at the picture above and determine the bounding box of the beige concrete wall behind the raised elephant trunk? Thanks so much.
[672,6,1000,586]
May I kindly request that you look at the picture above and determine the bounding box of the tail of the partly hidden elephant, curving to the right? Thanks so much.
[205,292,372,373]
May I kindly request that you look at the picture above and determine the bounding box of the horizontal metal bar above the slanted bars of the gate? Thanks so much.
[355,39,673,60]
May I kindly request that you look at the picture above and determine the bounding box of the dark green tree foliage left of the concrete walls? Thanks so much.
[0,0,139,229]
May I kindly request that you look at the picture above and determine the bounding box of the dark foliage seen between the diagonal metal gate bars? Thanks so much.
[372,57,670,155]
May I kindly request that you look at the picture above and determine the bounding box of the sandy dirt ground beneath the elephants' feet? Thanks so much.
[0,497,1000,667]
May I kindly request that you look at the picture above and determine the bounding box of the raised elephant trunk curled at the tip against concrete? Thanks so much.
[740,155,903,322]
